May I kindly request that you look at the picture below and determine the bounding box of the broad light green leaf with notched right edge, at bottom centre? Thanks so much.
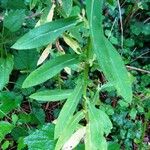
[85,102,112,150]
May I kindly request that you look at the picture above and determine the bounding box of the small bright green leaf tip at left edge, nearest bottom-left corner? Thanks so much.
[0,121,13,142]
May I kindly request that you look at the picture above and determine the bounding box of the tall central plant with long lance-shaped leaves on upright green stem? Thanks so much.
[12,0,132,150]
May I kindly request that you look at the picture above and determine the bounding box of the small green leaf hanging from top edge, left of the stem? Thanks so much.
[59,0,73,17]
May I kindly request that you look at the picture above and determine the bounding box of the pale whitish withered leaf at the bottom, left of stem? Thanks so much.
[62,127,86,150]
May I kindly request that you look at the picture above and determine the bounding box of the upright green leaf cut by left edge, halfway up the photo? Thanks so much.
[0,55,14,90]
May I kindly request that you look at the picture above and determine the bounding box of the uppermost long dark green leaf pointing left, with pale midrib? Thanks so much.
[12,17,79,50]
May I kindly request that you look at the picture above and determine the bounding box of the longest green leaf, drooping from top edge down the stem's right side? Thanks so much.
[86,0,132,103]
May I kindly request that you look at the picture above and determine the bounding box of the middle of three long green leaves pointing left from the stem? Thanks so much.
[22,55,79,88]
